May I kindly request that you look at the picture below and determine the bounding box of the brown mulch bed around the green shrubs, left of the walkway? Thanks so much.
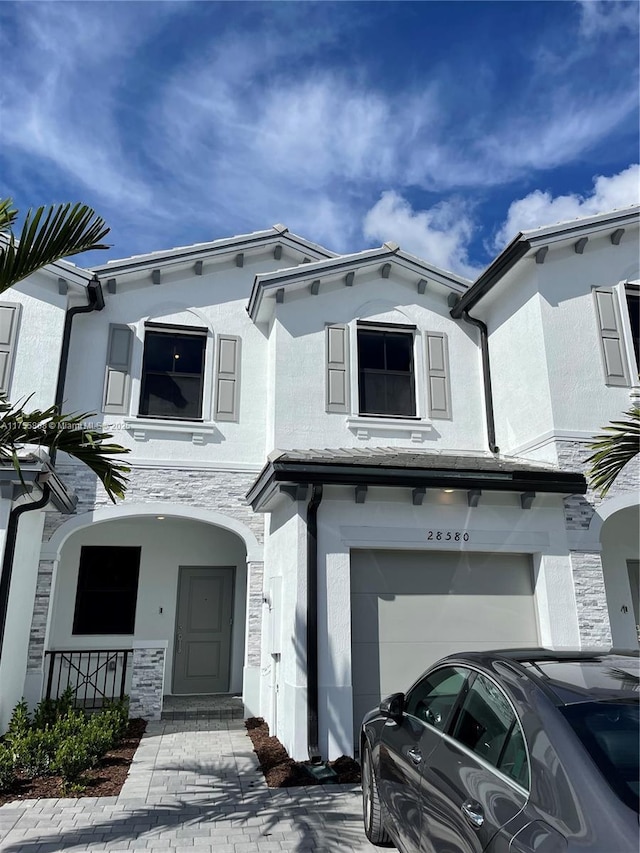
[0,720,147,805]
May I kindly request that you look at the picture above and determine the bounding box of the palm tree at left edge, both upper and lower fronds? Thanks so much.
[0,199,130,503]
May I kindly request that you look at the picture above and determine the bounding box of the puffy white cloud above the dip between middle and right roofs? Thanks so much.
[362,190,479,278]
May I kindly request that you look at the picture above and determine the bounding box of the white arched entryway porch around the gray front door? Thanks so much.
[27,504,262,716]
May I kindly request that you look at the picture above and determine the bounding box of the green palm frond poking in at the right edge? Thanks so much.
[587,406,640,498]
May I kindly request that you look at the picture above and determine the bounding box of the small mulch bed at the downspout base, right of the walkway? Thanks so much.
[245,717,360,788]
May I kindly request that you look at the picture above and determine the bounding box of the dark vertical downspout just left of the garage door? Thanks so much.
[307,483,322,764]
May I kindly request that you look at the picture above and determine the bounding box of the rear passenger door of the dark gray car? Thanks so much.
[421,673,529,853]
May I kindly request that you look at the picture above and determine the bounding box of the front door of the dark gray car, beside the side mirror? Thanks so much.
[378,666,469,853]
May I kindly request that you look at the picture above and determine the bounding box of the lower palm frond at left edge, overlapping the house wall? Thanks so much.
[0,398,131,503]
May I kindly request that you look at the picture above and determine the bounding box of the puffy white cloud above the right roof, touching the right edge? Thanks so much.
[494,164,640,251]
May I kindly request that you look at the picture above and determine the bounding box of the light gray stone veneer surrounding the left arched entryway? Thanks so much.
[27,465,264,671]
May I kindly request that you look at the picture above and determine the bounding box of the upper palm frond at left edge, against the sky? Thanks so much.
[0,199,110,293]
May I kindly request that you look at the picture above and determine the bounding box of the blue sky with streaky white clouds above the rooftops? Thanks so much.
[0,0,640,276]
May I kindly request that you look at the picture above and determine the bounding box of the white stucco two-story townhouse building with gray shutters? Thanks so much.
[0,207,640,759]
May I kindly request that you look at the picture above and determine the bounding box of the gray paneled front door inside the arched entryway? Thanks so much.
[173,567,234,693]
